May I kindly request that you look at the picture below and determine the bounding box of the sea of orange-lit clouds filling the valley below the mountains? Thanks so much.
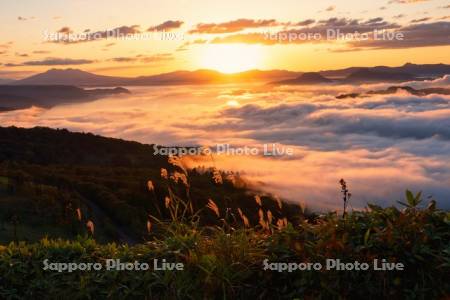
[0,76,450,209]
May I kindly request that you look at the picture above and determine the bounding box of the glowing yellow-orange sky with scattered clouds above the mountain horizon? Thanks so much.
[0,0,450,78]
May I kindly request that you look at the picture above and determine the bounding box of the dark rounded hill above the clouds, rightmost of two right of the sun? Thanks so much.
[343,68,417,83]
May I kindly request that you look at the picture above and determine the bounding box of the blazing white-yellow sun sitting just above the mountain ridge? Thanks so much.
[199,44,262,73]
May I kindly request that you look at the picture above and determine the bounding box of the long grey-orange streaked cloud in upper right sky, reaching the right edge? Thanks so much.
[199,15,450,51]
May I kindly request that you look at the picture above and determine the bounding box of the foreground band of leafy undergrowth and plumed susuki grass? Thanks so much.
[0,158,450,299]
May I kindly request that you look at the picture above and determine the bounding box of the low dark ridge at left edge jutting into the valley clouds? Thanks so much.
[0,85,129,111]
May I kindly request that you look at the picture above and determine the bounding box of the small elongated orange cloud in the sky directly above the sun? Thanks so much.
[189,19,279,34]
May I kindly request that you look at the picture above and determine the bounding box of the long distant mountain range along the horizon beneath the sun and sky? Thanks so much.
[12,63,450,86]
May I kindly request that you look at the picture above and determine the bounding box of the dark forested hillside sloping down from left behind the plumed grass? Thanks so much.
[0,127,298,243]
